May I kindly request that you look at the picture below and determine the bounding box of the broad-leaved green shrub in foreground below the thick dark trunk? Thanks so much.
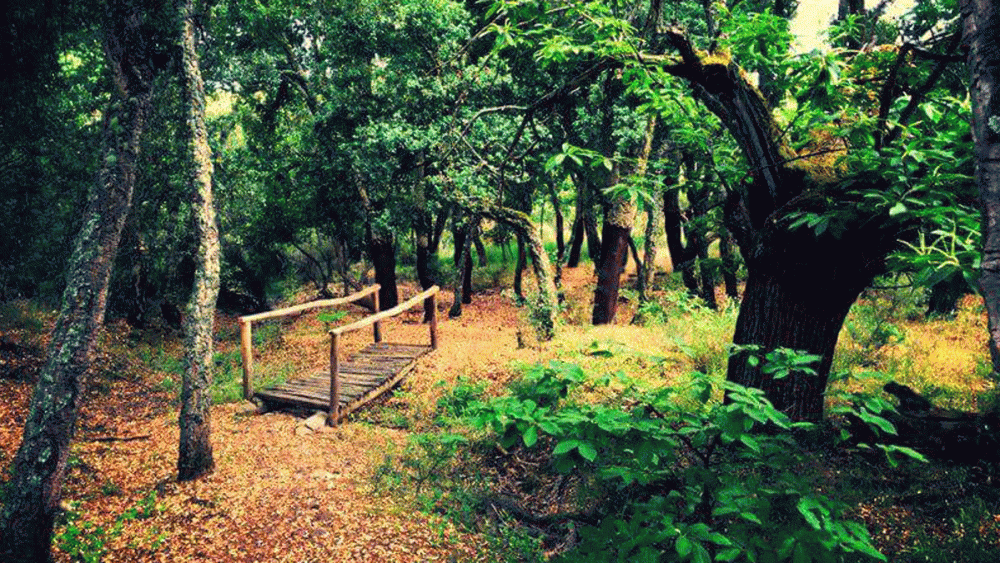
[477,362,885,562]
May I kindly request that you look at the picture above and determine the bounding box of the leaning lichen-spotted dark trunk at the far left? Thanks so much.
[0,2,154,563]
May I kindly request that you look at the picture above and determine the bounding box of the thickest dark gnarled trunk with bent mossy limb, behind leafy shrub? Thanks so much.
[663,30,903,420]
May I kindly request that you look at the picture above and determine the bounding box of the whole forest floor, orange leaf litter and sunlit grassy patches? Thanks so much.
[0,266,1000,562]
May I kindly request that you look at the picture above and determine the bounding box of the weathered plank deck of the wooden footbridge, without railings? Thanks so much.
[254,342,432,422]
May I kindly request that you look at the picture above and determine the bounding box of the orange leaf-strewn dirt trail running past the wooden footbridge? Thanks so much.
[0,268,593,563]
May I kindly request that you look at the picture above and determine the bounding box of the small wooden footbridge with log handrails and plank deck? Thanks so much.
[239,285,439,425]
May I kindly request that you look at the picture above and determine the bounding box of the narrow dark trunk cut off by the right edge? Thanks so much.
[963,0,1000,373]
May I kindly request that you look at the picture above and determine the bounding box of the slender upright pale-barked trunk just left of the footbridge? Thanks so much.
[177,0,219,481]
